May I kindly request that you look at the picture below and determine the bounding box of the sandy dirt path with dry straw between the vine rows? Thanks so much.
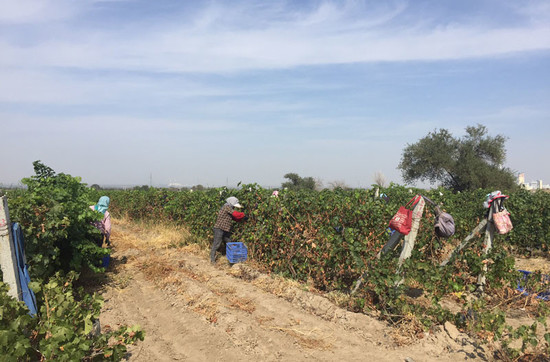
[101,221,491,361]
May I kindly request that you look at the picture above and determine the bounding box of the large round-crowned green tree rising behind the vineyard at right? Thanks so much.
[398,124,516,191]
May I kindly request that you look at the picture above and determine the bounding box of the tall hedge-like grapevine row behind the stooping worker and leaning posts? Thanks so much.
[107,184,550,293]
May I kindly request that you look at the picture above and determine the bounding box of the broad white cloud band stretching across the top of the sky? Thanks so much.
[0,2,550,72]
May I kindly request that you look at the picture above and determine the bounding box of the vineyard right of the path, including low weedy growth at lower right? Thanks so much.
[104,184,550,357]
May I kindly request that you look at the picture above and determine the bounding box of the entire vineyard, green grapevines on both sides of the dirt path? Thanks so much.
[0,163,550,360]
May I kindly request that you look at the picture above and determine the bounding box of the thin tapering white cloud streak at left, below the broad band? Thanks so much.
[0,67,260,105]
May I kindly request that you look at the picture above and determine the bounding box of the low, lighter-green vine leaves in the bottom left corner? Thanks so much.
[0,272,144,361]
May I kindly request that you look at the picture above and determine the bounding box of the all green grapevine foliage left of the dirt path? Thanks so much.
[0,161,143,361]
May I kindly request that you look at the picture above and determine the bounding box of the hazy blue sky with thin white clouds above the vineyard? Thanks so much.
[0,0,550,187]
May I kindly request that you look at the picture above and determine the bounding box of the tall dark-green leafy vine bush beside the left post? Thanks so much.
[8,161,108,279]
